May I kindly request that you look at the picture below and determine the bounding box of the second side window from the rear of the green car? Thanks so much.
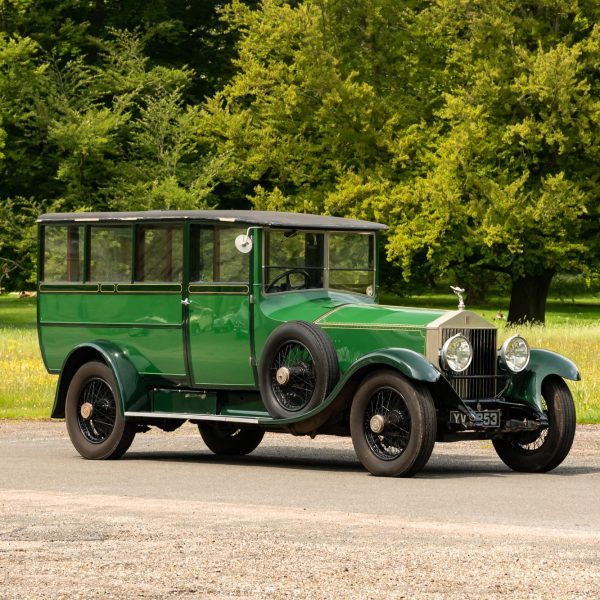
[90,226,131,281]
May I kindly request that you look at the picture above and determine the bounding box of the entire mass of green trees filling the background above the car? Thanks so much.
[0,0,600,321]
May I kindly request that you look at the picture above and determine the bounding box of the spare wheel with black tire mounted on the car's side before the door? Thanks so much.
[259,321,339,418]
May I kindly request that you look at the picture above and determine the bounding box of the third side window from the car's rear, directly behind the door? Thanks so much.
[135,225,183,282]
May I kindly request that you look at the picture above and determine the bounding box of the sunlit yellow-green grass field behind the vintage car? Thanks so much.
[0,296,600,423]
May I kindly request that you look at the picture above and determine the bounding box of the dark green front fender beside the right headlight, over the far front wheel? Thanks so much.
[505,348,581,412]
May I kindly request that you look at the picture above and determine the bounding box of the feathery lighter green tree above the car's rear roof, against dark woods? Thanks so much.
[46,31,217,210]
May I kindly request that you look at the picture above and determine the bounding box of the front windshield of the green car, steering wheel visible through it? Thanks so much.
[264,230,375,295]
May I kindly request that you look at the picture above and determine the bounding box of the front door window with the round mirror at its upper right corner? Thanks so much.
[190,225,249,283]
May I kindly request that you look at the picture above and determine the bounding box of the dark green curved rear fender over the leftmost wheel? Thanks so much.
[51,340,147,419]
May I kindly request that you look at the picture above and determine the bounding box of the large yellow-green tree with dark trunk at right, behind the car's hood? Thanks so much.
[388,0,600,323]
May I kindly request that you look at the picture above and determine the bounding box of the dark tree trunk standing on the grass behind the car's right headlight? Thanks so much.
[507,271,554,325]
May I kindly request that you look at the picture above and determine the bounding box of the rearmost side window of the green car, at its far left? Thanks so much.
[42,225,83,281]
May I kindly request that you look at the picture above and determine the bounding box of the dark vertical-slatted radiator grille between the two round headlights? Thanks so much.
[442,329,500,400]
